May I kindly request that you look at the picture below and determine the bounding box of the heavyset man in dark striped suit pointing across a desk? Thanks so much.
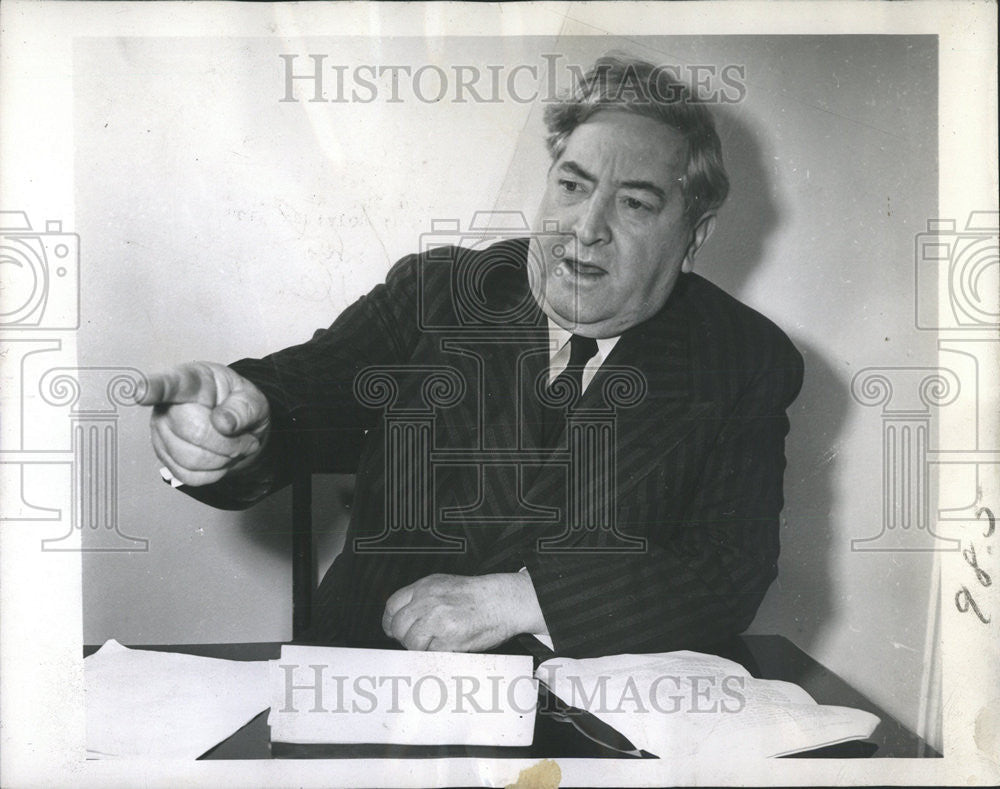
[140,57,802,657]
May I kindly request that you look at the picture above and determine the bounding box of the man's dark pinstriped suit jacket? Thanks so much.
[193,239,802,657]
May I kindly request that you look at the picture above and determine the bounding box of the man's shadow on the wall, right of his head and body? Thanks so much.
[696,107,850,651]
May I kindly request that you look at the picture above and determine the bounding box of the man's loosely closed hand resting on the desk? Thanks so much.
[382,573,547,652]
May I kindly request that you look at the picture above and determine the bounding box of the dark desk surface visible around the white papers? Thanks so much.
[84,635,940,759]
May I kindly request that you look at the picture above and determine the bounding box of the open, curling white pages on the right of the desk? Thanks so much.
[537,652,879,758]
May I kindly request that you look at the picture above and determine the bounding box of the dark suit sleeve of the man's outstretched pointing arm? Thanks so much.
[181,255,419,509]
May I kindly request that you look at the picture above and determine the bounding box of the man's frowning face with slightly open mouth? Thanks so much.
[529,110,708,338]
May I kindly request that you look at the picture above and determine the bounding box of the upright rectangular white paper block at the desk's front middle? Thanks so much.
[268,646,538,746]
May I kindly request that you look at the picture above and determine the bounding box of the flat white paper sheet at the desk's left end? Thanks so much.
[84,640,269,759]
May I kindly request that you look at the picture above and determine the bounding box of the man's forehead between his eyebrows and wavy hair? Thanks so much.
[556,110,687,180]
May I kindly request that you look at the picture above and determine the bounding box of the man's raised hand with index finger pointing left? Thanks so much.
[135,362,270,486]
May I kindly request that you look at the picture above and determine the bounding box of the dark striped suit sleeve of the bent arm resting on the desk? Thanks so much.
[525,340,802,657]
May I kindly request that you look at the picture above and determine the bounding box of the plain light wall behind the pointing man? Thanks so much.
[74,35,937,744]
